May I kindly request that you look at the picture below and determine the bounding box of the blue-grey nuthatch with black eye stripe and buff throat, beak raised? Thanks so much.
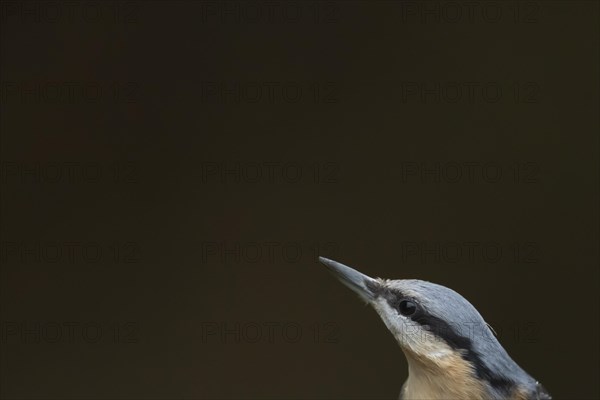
[319,257,552,400]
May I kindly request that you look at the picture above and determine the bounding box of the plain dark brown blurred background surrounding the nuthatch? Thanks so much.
[0,1,600,399]
